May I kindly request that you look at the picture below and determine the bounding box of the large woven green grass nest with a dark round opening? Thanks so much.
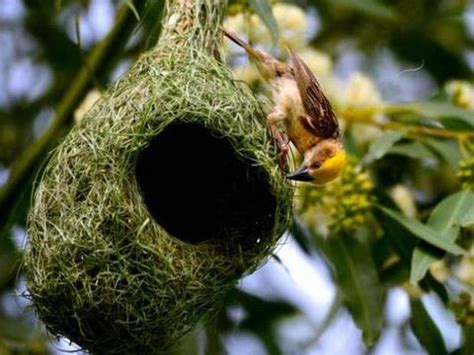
[24,0,291,354]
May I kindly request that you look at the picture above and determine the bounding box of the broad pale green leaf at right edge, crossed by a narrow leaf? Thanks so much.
[410,191,474,282]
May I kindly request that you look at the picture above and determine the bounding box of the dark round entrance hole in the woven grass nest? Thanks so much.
[136,123,276,247]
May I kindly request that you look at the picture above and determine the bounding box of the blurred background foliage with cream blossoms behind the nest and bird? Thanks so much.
[0,0,474,354]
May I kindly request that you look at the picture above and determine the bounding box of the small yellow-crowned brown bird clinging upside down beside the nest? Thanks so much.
[222,28,347,185]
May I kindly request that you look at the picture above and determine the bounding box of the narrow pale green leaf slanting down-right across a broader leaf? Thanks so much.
[377,205,466,255]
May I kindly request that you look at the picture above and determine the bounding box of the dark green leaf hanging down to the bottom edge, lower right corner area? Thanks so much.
[410,299,448,355]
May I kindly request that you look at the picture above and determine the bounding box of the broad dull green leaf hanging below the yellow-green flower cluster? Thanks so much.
[325,233,385,346]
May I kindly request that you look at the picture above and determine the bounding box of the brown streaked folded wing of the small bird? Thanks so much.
[291,53,340,138]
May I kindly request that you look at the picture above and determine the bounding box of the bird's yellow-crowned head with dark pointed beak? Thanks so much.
[287,140,347,185]
